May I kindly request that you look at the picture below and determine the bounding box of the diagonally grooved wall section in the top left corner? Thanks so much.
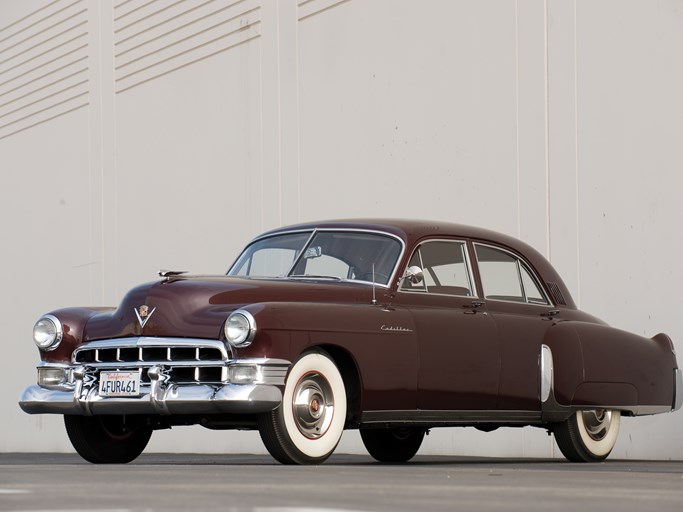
[0,0,89,139]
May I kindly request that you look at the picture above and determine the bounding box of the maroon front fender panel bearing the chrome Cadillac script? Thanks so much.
[238,302,419,410]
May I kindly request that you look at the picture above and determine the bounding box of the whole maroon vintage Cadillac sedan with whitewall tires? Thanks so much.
[19,220,683,464]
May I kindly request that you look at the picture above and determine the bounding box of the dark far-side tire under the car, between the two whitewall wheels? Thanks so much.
[360,427,425,462]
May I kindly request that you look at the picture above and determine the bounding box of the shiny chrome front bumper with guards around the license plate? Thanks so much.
[19,358,291,416]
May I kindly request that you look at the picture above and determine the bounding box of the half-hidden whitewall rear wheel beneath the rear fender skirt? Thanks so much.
[553,409,621,462]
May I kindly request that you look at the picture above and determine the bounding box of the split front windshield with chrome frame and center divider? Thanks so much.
[228,231,401,285]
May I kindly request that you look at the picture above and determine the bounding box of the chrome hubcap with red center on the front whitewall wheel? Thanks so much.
[292,372,334,439]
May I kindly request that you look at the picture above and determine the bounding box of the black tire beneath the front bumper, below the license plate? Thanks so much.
[64,415,152,464]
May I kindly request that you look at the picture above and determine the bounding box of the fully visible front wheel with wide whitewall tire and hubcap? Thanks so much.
[258,350,346,464]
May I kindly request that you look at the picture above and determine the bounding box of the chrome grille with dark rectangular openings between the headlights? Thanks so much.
[72,338,229,384]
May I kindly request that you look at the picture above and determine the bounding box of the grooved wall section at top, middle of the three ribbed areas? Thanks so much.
[114,0,261,93]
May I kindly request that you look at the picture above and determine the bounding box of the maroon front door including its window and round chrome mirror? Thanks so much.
[397,239,500,411]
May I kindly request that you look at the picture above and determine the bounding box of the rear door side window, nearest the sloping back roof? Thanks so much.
[475,244,549,304]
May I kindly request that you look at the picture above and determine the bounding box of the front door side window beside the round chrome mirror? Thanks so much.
[401,240,473,296]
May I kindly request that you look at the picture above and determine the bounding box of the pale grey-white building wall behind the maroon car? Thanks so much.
[0,0,683,459]
